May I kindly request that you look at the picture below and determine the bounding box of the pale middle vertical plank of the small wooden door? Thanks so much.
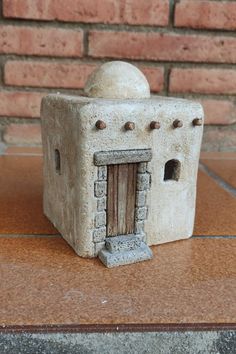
[117,164,128,235]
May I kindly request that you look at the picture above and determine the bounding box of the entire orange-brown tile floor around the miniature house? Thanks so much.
[0,148,236,328]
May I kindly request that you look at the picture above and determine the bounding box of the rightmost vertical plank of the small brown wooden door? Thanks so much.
[126,163,137,234]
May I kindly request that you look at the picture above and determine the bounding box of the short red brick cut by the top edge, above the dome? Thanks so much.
[120,0,169,26]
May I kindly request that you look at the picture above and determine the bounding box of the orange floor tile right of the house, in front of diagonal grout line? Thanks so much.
[194,171,236,235]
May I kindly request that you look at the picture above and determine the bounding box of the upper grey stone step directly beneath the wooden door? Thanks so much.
[105,234,142,253]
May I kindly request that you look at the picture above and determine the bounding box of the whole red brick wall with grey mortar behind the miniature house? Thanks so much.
[0,0,236,151]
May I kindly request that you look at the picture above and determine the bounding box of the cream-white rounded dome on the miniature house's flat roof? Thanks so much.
[84,61,150,99]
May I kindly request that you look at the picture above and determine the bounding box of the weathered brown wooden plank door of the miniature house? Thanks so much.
[107,163,137,236]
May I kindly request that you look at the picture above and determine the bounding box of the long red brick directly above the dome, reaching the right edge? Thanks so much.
[89,31,236,63]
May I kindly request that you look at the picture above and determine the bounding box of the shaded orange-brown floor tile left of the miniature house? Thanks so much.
[0,156,57,234]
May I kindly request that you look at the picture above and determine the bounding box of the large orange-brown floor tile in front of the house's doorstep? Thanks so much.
[0,237,236,325]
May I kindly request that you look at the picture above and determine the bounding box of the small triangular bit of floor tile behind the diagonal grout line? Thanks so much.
[201,159,236,188]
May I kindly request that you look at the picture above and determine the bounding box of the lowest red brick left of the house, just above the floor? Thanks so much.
[3,124,41,145]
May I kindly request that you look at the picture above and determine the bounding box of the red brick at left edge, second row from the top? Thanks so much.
[0,25,83,57]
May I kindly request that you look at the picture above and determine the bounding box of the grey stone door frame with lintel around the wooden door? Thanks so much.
[93,149,152,255]
